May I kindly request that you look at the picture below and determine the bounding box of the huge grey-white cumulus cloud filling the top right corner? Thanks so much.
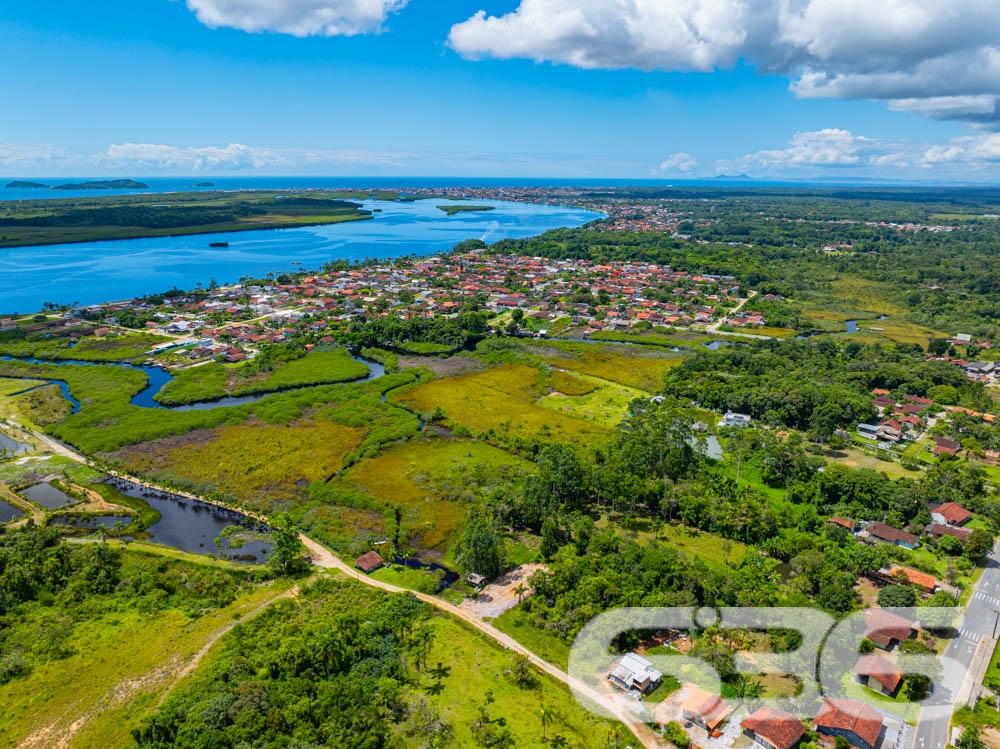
[448,0,1000,123]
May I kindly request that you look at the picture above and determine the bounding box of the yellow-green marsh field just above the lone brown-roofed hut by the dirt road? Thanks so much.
[340,439,528,552]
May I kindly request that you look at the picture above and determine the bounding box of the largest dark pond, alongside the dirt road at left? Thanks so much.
[108,478,271,563]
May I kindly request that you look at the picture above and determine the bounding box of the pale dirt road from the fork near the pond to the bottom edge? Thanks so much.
[299,534,670,749]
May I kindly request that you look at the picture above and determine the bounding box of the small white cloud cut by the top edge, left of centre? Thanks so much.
[187,0,407,36]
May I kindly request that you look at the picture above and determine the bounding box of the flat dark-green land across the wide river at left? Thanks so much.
[0,191,380,247]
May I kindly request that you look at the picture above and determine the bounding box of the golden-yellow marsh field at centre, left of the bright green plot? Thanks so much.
[399,365,611,445]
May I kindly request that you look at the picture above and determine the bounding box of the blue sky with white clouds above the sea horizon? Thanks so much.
[0,0,1000,183]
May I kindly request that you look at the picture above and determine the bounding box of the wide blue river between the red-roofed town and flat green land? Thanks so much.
[0,200,603,314]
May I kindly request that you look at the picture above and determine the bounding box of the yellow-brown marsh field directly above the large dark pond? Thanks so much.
[110,420,364,510]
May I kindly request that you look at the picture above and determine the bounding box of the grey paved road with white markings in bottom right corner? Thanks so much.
[911,543,1000,749]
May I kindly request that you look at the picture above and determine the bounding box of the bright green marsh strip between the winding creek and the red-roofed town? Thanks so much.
[156,349,368,405]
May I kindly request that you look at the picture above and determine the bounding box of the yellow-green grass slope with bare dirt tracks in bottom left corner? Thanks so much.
[0,582,289,747]
